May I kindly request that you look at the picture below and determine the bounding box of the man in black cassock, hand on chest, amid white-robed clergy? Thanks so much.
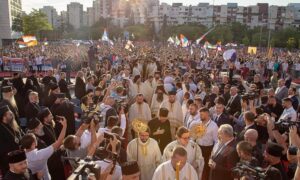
[148,108,172,152]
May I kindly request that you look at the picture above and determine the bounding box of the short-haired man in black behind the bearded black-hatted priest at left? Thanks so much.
[25,92,42,122]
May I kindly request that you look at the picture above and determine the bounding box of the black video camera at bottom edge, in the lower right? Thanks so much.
[231,162,267,180]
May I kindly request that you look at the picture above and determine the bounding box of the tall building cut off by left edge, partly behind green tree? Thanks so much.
[0,0,22,46]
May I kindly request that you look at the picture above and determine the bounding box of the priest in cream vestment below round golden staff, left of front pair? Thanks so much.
[127,128,161,180]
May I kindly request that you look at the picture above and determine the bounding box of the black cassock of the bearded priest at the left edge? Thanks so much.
[0,123,23,174]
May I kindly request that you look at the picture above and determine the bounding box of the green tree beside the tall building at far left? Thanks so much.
[23,9,52,37]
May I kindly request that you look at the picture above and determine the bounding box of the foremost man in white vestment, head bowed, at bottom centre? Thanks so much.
[152,147,199,180]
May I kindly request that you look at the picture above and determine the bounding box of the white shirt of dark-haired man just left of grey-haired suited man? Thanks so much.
[195,120,219,146]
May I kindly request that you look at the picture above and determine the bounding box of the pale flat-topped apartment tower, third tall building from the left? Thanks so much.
[67,2,83,29]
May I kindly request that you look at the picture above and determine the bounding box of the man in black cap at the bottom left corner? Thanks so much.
[4,150,38,180]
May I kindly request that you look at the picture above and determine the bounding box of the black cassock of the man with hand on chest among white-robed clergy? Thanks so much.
[148,118,172,153]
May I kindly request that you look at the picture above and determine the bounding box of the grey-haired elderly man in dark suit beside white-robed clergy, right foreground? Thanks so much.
[209,124,239,180]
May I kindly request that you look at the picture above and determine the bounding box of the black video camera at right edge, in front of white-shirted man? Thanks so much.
[274,117,300,135]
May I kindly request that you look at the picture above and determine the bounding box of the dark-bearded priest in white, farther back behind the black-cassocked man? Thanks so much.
[150,84,168,117]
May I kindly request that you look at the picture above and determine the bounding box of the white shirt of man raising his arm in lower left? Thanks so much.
[26,145,54,180]
